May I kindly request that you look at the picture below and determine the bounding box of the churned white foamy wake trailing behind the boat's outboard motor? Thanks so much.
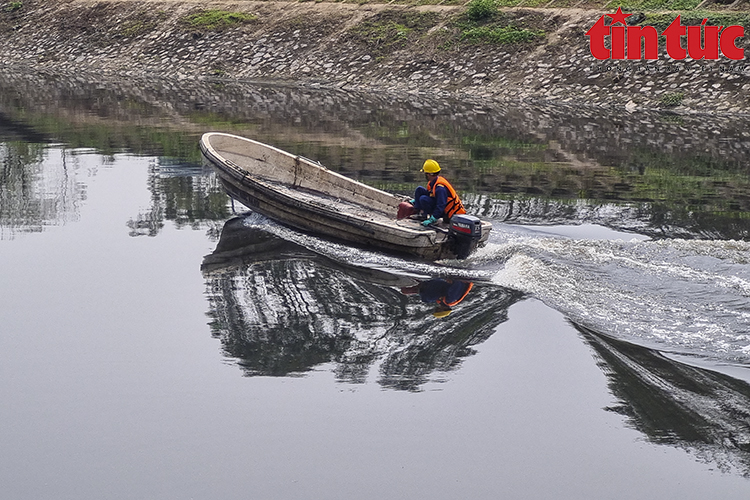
[484,228,750,363]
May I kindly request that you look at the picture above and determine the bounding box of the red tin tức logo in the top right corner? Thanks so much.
[586,7,745,60]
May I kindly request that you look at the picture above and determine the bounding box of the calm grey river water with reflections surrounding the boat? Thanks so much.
[0,73,750,499]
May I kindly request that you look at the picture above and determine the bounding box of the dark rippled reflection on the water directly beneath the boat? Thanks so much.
[202,218,523,390]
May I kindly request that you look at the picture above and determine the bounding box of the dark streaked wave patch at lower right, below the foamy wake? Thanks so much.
[576,326,750,477]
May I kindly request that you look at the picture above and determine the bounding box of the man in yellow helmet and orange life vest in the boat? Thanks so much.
[411,160,466,227]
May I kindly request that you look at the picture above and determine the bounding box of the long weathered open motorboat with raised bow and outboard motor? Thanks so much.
[200,132,492,260]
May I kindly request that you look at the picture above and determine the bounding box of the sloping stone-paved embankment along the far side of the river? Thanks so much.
[0,0,750,114]
